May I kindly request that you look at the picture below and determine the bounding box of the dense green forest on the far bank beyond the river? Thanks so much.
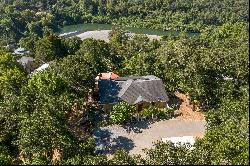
[0,0,249,43]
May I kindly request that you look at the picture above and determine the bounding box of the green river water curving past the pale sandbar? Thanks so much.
[58,23,197,36]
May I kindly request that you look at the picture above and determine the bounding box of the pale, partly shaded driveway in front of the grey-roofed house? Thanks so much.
[93,119,206,156]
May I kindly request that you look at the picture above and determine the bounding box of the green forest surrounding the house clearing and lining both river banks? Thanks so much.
[0,0,249,165]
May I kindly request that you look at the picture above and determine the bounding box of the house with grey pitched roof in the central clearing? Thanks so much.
[98,75,169,111]
